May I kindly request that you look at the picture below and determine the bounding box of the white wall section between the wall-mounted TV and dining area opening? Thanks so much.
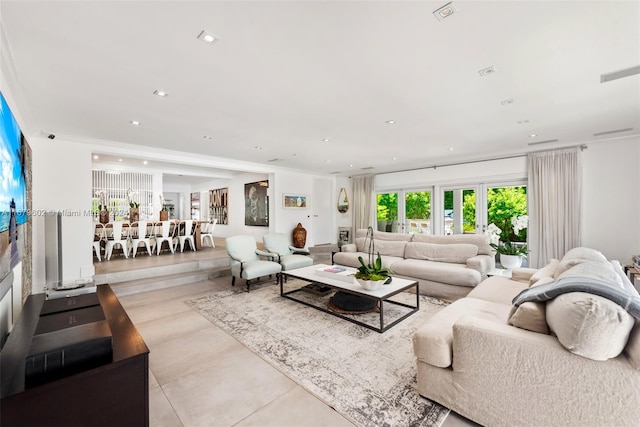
[29,137,94,293]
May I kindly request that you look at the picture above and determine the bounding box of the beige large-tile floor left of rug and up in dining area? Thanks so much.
[105,242,474,427]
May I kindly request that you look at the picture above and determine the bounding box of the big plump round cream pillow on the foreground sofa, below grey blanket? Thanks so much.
[546,292,635,360]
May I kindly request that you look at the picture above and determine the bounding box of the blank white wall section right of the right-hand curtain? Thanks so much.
[582,137,640,264]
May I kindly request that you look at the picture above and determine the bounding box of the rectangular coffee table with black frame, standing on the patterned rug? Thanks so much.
[280,264,420,333]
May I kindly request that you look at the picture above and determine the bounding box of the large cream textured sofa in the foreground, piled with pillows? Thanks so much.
[413,248,640,426]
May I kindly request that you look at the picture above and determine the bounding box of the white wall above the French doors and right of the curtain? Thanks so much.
[375,137,640,264]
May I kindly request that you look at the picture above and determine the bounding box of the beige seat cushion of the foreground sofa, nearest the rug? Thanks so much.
[413,298,509,368]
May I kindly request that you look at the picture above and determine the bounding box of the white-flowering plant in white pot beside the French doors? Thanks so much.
[485,215,529,269]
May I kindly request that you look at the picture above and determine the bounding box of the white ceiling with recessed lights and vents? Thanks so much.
[0,1,640,175]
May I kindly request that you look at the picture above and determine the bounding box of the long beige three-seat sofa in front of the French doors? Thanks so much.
[333,229,495,301]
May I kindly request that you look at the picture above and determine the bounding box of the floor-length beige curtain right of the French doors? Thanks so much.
[527,147,582,268]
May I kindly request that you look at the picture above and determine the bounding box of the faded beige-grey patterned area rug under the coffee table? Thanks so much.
[187,283,449,427]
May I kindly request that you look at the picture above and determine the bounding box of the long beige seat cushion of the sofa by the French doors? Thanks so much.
[392,259,482,287]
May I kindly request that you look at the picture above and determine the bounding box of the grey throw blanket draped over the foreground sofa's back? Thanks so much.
[512,277,640,319]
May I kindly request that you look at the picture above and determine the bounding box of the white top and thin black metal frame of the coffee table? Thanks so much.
[280,264,420,333]
